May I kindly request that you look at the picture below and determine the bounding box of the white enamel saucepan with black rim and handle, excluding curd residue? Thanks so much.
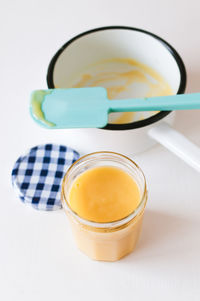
[47,26,200,171]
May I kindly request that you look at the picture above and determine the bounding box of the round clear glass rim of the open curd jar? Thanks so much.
[61,151,147,229]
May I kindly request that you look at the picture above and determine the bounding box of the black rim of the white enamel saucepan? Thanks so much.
[47,26,187,130]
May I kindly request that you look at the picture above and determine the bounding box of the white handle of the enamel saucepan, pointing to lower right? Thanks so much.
[148,122,200,172]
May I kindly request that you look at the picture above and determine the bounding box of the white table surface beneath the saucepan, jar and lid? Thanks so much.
[0,0,200,301]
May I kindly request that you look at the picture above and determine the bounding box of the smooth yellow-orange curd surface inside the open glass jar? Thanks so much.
[69,166,140,223]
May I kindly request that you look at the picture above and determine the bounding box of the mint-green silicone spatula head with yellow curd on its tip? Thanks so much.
[30,87,109,129]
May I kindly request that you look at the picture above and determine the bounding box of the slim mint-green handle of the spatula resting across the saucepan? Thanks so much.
[109,93,200,112]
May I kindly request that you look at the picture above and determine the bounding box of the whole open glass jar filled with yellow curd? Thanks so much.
[61,151,147,261]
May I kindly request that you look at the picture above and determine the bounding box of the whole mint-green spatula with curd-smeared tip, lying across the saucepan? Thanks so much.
[30,87,200,129]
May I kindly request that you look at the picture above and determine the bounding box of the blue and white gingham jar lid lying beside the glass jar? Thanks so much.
[12,144,79,210]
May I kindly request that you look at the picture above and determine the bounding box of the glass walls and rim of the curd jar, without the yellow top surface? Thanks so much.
[61,151,147,261]
